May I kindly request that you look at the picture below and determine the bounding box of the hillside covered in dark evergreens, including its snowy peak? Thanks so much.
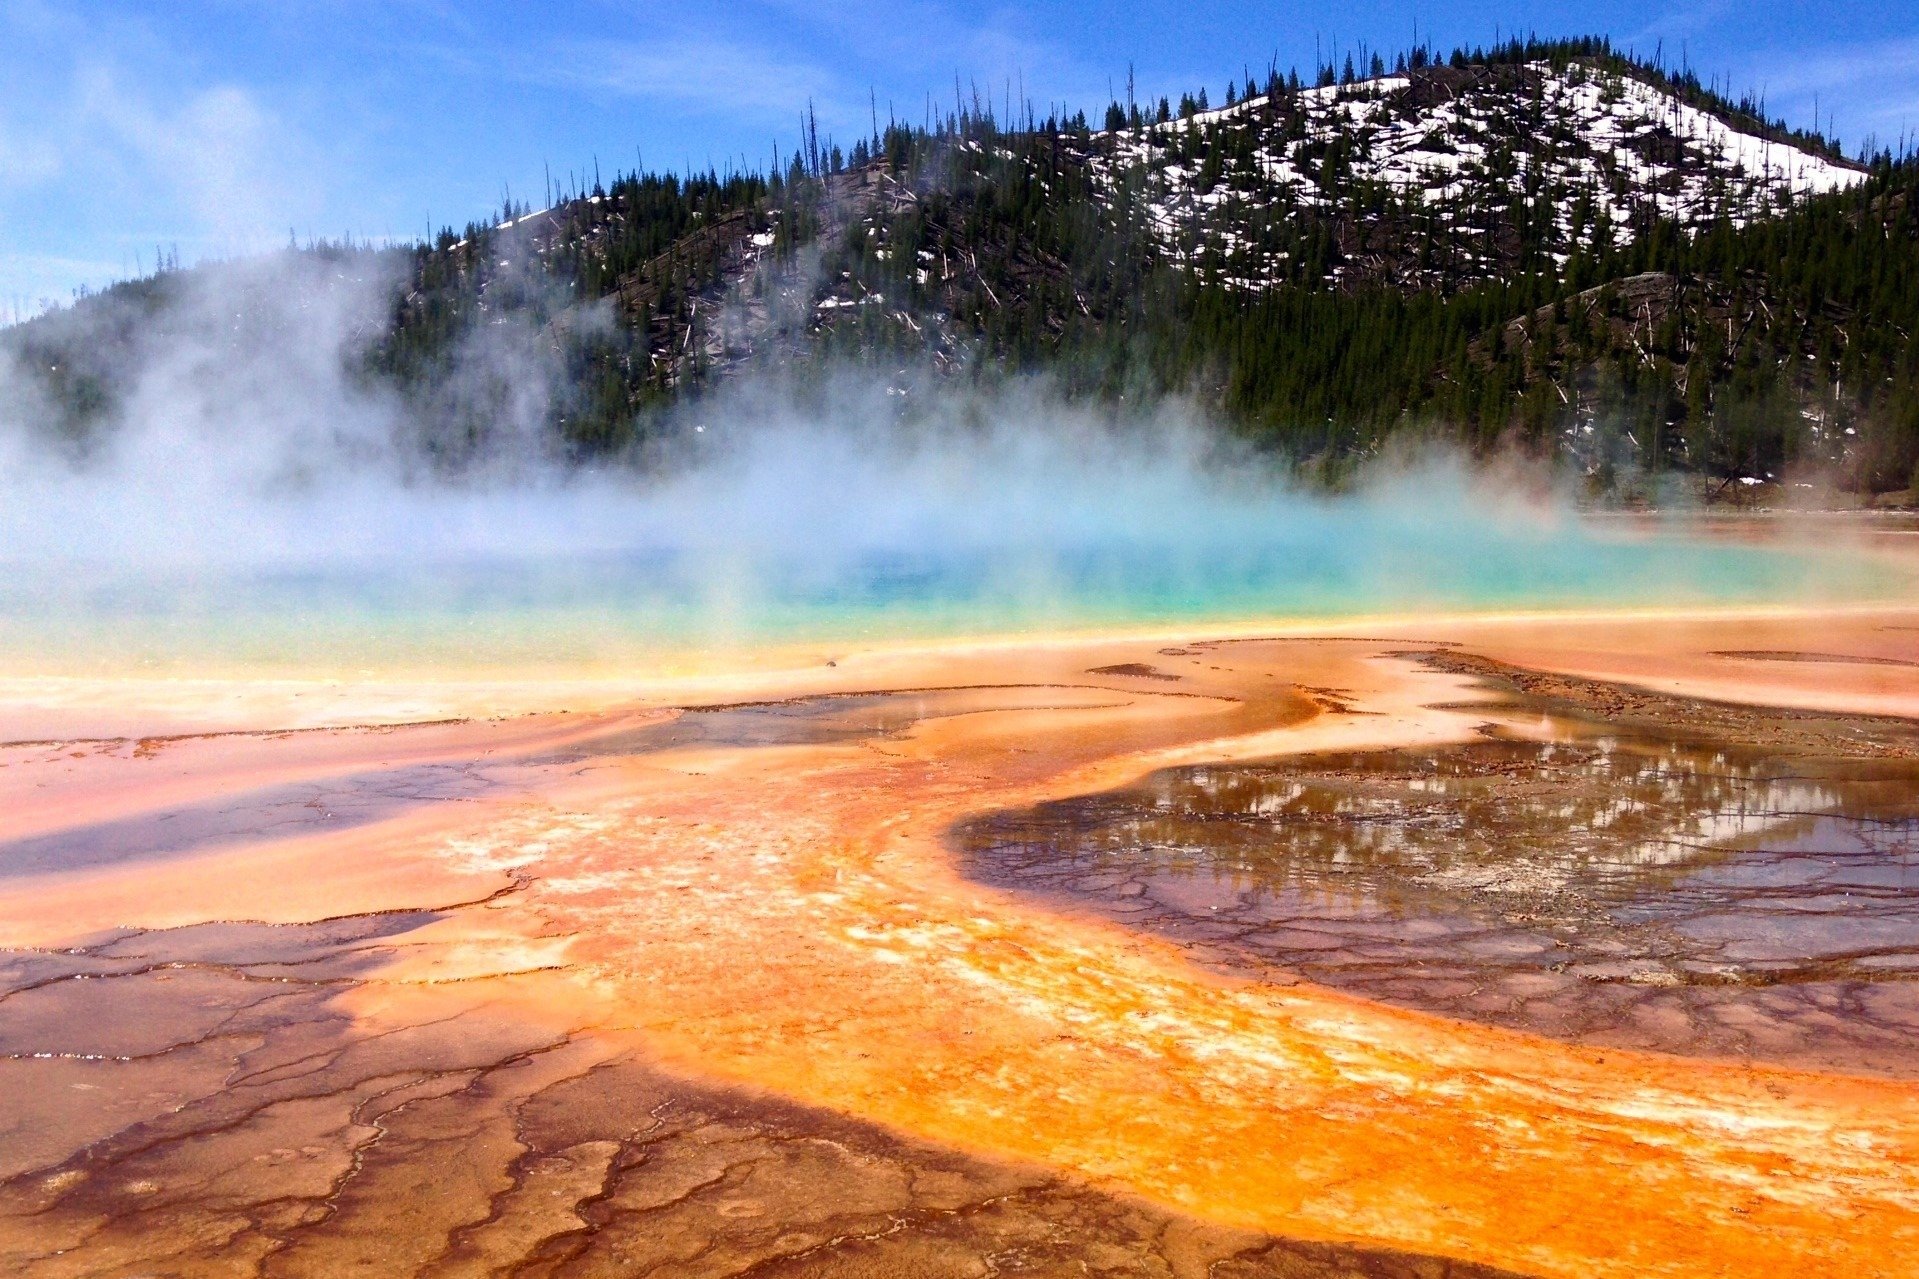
[0,38,1919,494]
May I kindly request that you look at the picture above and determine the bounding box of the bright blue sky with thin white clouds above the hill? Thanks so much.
[0,0,1919,319]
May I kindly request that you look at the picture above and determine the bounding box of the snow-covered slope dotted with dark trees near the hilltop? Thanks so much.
[1090,61,1865,288]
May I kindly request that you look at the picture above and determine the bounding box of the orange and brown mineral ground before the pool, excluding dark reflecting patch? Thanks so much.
[0,609,1919,1275]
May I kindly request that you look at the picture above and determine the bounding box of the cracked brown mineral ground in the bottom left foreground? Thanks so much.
[0,860,1501,1279]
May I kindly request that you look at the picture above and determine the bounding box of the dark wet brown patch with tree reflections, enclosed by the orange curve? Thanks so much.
[954,655,1919,1077]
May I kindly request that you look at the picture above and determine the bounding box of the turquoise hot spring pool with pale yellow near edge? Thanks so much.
[0,505,1913,674]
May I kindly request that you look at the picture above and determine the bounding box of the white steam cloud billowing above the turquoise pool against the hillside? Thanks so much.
[0,253,1558,565]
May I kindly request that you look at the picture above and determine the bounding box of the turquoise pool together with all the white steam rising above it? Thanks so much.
[0,259,1909,672]
